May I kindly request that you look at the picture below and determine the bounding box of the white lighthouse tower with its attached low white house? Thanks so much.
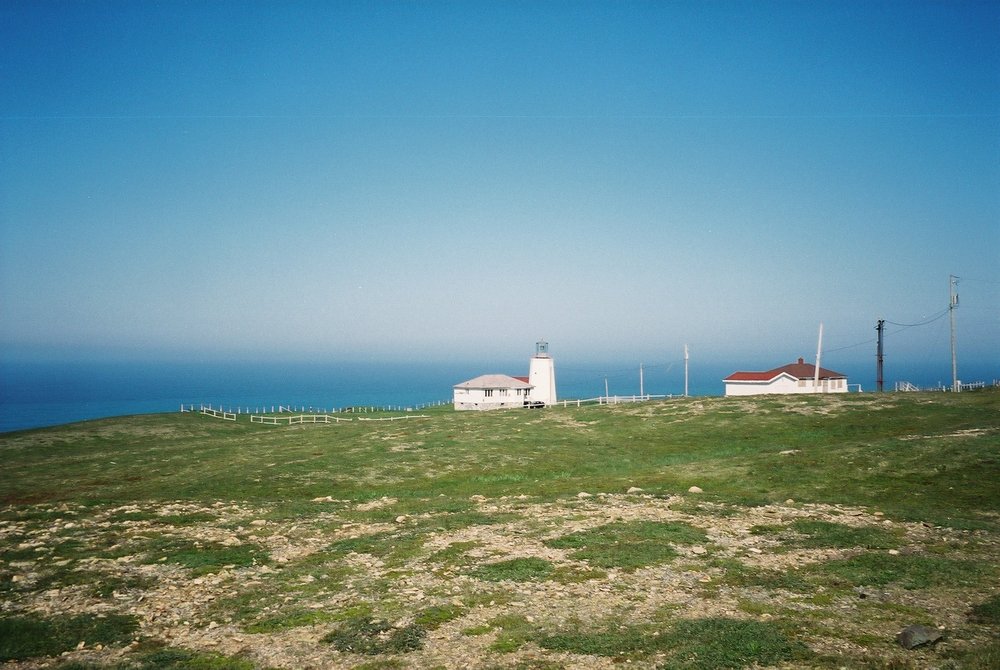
[452,341,556,410]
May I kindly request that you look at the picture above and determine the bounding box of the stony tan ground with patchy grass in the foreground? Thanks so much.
[0,489,1000,668]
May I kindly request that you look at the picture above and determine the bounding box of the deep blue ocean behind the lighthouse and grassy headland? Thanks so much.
[0,357,992,432]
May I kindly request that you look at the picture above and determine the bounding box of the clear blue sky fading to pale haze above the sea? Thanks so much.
[0,0,1000,374]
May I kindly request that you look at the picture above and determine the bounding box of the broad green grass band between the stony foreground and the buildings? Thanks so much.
[0,390,1000,528]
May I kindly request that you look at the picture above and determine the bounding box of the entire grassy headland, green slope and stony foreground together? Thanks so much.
[0,390,1000,670]
